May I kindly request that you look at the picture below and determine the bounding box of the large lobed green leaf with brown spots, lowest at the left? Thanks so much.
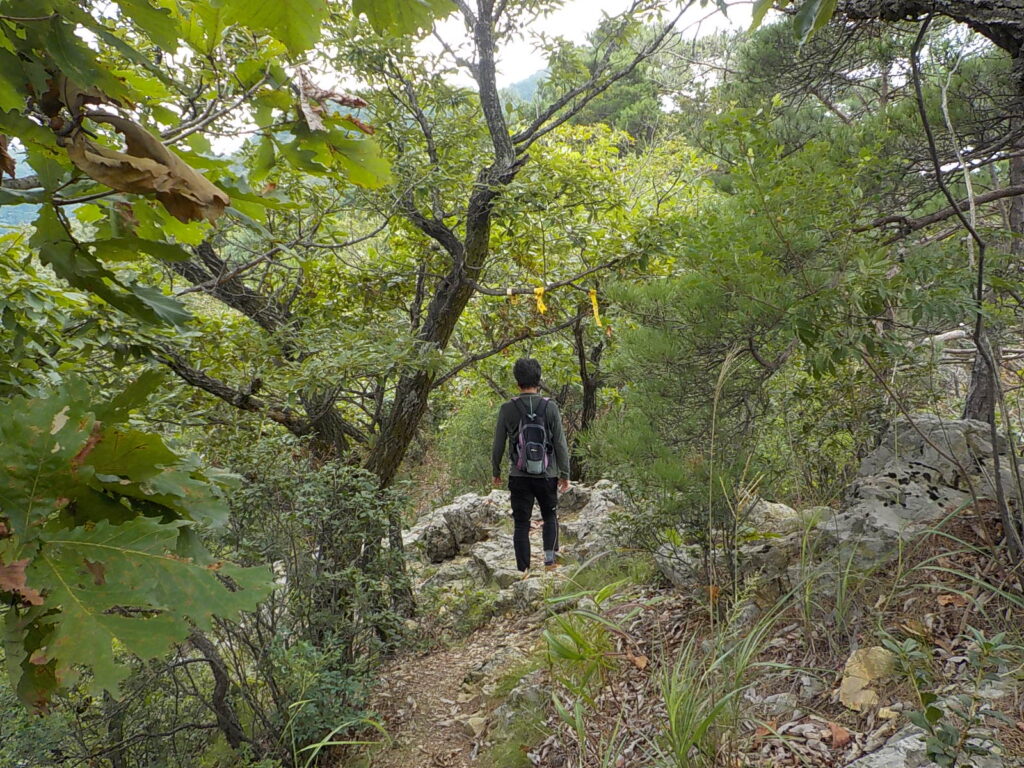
[27,517,270,693]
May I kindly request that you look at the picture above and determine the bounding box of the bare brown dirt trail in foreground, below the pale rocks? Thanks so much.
[370,616,540,768]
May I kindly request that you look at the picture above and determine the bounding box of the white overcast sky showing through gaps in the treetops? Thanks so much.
[421,0,752,88]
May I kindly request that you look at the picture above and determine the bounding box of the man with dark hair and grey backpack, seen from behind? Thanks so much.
[490,357,569,575]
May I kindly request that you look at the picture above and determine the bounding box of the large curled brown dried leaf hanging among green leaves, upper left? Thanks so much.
[63,113,231,221]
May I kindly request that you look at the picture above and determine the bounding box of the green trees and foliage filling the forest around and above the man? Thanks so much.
[0,0,1024,768]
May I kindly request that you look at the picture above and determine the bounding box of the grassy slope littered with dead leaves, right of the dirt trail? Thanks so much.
[489,508,1024,768]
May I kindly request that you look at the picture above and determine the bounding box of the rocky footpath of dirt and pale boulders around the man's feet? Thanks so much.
[356,482,622,768]
